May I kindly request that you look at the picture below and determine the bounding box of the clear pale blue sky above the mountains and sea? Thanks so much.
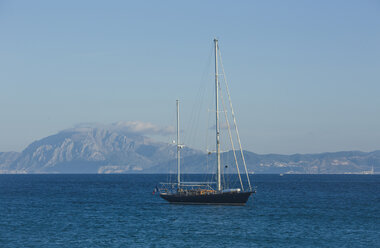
[0,0,380,154]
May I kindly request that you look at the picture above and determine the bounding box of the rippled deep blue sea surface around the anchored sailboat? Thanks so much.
[0,174,380,247]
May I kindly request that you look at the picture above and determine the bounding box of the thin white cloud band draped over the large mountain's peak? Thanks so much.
[64,121,175,136]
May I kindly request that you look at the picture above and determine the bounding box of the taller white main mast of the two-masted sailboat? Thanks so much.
[214,39,222,191]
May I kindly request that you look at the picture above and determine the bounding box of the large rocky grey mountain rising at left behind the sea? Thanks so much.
[3,127,199,173]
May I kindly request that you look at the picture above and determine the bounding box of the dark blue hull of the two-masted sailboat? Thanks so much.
[160,192,253,205]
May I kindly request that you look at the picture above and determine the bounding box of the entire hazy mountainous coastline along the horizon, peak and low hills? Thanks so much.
[0,126,380,175]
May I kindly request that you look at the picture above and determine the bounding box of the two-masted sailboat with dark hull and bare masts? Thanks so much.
[157,39,255,205]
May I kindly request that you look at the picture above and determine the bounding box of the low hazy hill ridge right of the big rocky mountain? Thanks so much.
[148,150,380,174]
